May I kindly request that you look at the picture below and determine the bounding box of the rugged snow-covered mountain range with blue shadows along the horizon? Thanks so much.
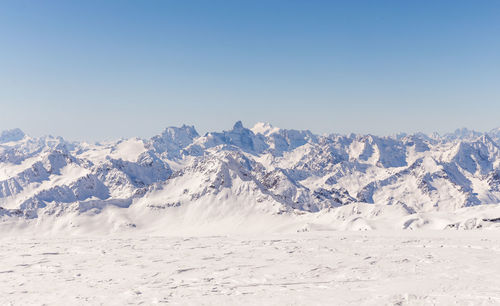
[0,121,500,231]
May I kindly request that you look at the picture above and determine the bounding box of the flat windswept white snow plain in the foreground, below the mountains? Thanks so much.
[0,230,500,305]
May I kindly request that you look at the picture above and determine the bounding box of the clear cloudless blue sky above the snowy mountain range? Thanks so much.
[0,0,500,140]
